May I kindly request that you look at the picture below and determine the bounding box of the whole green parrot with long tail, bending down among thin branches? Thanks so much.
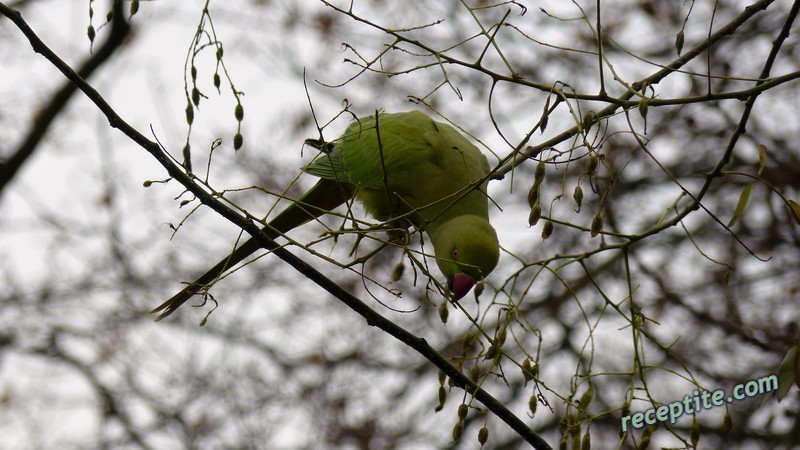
[150,111,500,321]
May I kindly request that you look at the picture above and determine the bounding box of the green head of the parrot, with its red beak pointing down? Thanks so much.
[431,215,500,300]
